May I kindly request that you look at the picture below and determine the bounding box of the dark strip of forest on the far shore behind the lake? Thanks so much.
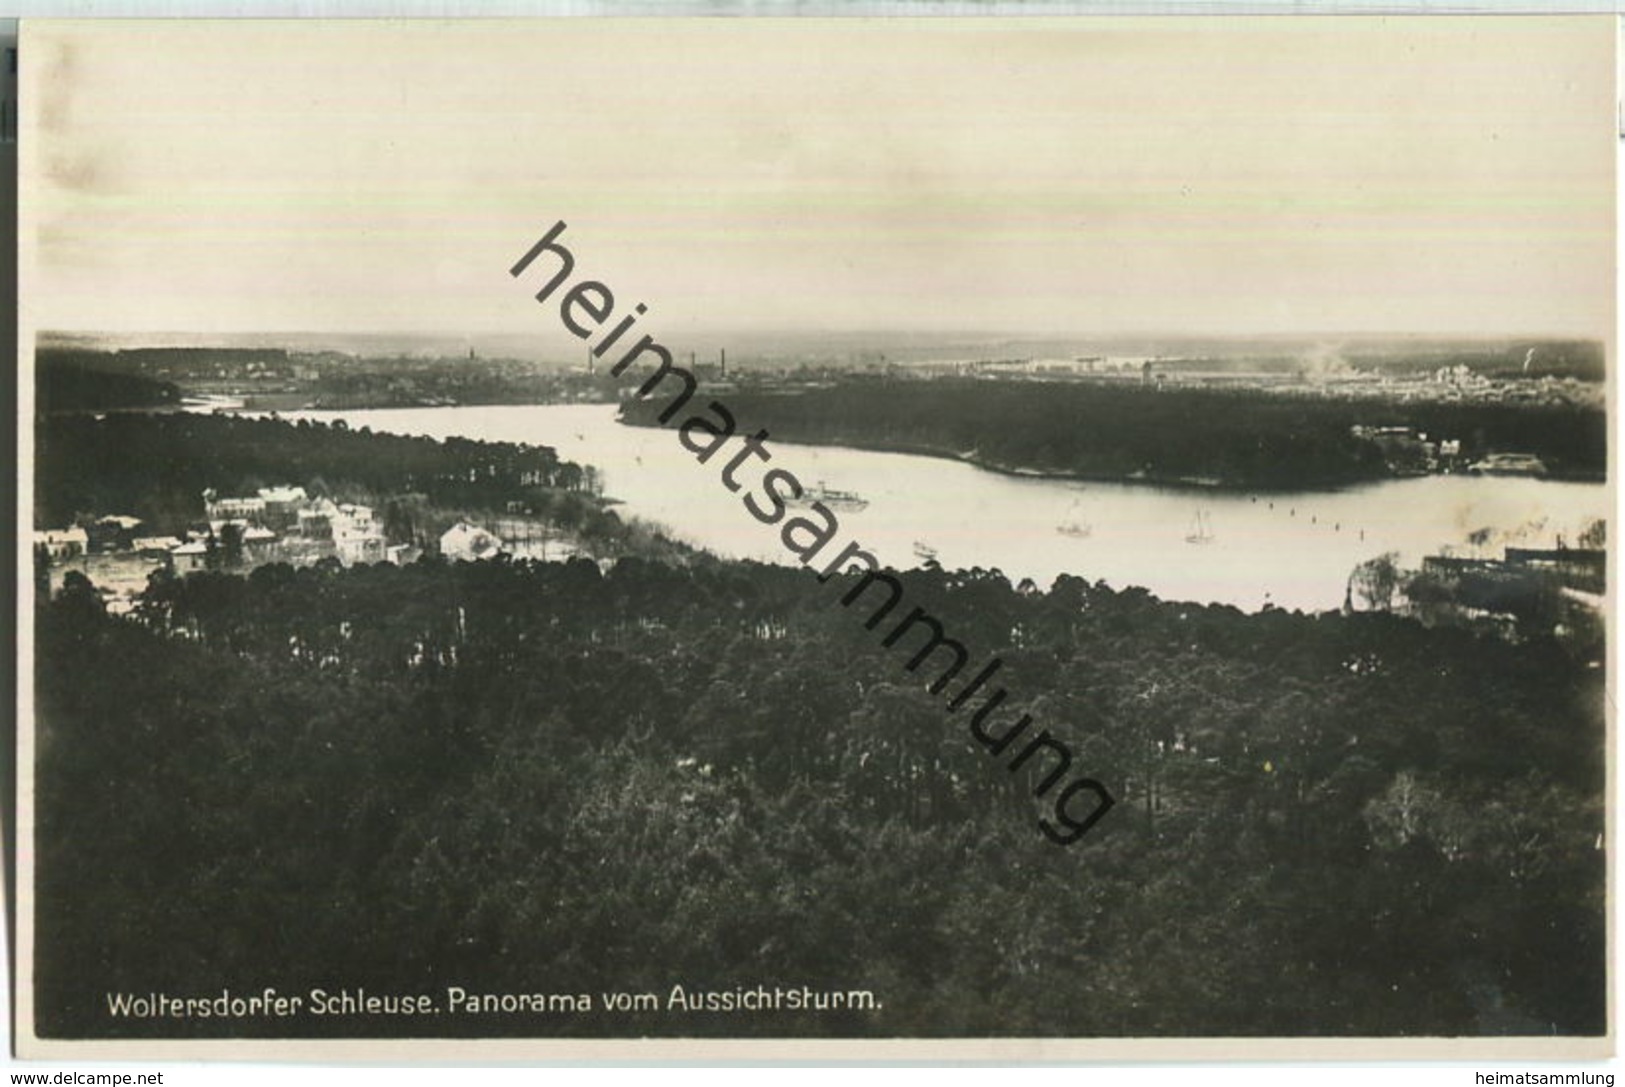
[622,379,1607,489]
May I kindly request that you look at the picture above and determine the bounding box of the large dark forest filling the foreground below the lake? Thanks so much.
[36,555,1606,1037]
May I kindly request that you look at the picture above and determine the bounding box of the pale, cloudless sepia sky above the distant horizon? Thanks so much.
[21,16,1615,340]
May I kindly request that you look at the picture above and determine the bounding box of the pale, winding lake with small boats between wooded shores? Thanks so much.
[286,405,1610,611]
